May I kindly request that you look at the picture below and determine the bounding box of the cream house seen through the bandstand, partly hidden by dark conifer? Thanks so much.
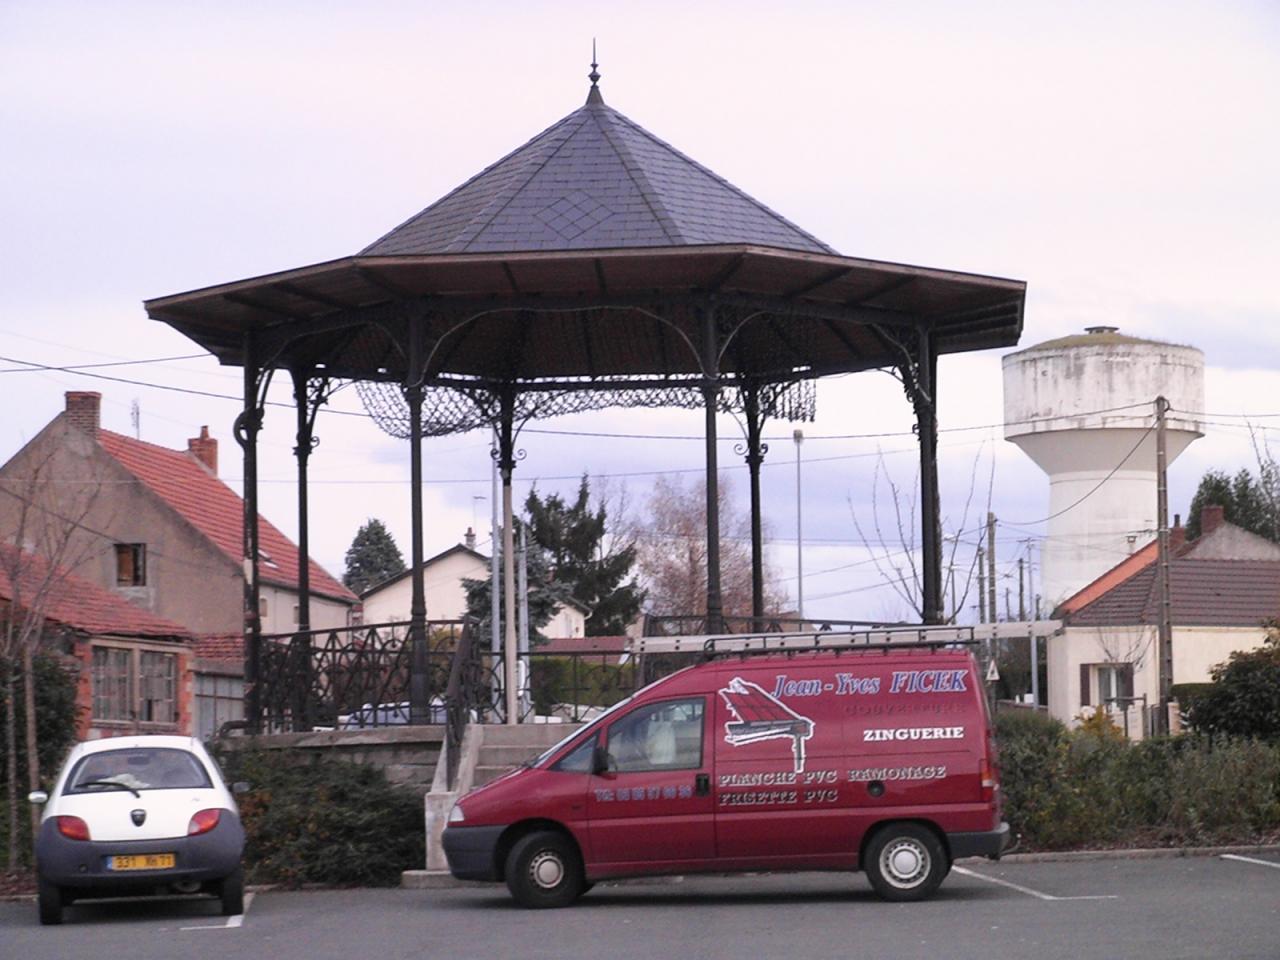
[360,542,591,636]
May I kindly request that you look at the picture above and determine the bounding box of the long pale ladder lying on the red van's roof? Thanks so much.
[631,620,1062,659]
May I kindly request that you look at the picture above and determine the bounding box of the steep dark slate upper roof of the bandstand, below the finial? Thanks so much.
[361,88,836,256]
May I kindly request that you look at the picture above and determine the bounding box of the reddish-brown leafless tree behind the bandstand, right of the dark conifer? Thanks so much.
[635,476,787,617]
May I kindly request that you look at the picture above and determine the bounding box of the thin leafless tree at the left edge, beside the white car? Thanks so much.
[0,445,102,869]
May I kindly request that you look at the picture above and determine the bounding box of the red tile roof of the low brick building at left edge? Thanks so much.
[0,544,191,640]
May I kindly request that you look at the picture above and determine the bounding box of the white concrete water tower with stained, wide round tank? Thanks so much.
[1004,326,1204,611]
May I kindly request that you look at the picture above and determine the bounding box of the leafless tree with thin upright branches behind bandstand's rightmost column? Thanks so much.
[849,444,996,623]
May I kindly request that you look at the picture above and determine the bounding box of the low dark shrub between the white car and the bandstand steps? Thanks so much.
[220,750,425,887]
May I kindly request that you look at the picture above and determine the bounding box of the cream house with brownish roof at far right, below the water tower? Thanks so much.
[1048,507,1280,736]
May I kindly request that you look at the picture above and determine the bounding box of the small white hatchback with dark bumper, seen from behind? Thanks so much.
[29,736,244,924]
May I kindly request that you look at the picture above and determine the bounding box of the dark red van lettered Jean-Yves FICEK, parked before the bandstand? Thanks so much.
[444,643,1009,908]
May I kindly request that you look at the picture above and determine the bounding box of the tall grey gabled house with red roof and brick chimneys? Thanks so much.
[0,392,358,635]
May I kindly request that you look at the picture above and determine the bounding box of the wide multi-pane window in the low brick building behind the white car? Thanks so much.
[92,646,178,726]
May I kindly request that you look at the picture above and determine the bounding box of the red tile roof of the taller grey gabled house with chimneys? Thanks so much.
[97,430,357,603]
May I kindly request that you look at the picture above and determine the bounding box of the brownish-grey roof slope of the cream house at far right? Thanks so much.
[1068,557,1280,627]
